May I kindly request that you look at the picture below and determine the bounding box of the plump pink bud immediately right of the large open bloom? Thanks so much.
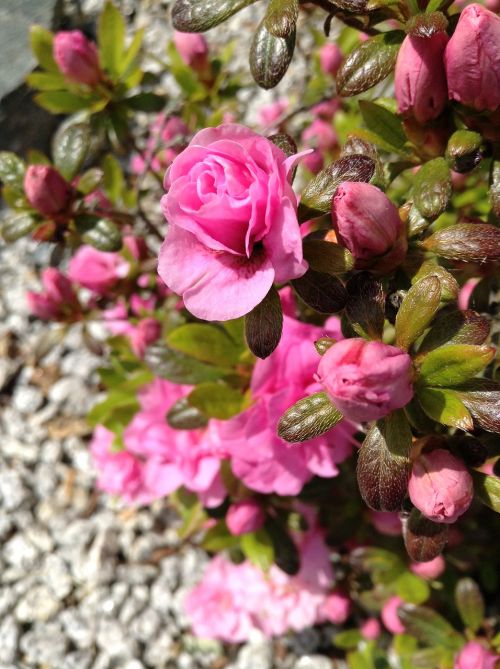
[332,181,406,271]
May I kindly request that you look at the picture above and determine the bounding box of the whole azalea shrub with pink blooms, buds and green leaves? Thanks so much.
[0,0,500,669]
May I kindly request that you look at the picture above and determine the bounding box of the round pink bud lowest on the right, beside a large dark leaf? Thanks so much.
[408,448,474,523]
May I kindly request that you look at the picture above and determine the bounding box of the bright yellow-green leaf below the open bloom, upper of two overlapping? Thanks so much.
[167,323,240,367]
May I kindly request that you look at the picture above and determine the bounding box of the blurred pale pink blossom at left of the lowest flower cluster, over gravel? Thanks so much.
[184,555,267,643]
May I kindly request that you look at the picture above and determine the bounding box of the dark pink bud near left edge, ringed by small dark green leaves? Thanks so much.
[24,165,73,216]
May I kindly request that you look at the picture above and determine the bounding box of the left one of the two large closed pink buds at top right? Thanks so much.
[394,32,448,123]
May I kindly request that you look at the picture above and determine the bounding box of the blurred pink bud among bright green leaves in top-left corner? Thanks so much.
[53,30,102,86]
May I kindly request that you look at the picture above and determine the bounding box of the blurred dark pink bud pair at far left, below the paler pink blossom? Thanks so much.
[26,267,80,321]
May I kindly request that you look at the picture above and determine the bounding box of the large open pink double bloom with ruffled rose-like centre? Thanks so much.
[158,124,307,321]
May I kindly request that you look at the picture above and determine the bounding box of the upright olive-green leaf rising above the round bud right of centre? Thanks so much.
[395,274,441,351]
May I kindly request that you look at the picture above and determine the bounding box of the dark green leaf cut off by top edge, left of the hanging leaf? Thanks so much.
[172,0,256,33]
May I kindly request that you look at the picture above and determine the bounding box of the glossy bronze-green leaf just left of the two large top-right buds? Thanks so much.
[336,30,405,97]
